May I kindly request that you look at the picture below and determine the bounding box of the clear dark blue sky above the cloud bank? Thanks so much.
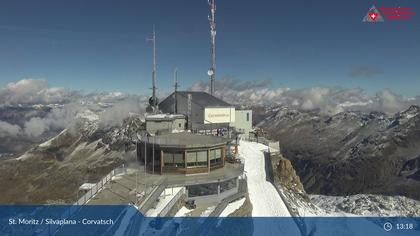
[0,0,420,96]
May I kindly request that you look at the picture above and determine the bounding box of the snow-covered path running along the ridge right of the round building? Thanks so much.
[239,141,301,235]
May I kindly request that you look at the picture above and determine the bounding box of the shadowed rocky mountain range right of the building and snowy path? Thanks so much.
[255,106,420,199]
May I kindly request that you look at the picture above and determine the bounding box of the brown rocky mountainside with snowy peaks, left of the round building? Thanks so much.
[0,114,141,204]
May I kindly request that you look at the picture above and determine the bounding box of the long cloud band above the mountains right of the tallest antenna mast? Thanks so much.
[191,78,420,114]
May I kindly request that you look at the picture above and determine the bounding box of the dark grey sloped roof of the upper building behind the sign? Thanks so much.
[159,91,232,107]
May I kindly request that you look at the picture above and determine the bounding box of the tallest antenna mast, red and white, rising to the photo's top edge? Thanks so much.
[207,0,216,95]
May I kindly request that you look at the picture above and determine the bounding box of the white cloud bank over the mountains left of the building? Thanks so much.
[0,79,151,137]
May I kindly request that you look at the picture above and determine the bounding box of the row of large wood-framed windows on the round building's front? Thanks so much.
[163,149,222,167]
